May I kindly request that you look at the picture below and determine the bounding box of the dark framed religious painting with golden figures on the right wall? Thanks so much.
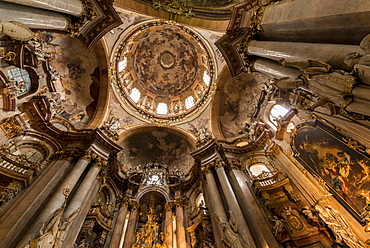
[291,121,370,220]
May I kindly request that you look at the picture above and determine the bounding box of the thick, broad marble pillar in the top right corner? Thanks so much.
[261,0,370,44]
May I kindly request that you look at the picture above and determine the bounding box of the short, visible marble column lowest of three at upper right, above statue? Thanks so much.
[253,59,302,79]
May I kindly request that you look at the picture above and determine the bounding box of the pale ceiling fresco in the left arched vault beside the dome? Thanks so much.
[37,32,100,129]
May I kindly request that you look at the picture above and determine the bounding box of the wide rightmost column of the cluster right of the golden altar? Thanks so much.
[229,164,280,248]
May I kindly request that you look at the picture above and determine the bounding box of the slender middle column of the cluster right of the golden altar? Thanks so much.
[216,163,256,248]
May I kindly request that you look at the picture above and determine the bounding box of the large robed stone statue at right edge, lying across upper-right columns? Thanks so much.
[275,35,370,116]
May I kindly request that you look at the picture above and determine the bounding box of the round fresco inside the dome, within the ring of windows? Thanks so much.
[133,27,200,99]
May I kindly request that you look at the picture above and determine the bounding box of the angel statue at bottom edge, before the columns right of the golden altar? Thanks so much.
[213,210,250,248]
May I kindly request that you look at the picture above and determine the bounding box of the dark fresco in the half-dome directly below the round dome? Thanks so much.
[119,131,194,173]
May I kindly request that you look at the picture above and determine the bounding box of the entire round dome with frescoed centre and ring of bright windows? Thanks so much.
[109,21,215,125]
